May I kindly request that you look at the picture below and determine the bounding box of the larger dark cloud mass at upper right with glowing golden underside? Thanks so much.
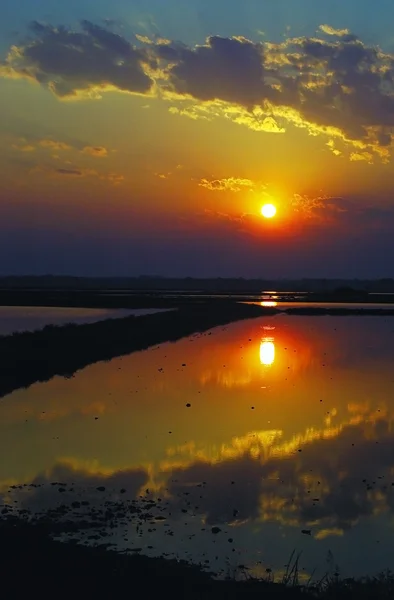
[156,35,394,156]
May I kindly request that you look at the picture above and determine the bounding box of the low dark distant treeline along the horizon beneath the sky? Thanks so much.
[0,275,394,293]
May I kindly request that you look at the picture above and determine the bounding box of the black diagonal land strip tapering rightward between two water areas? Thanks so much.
[0,302,262,397]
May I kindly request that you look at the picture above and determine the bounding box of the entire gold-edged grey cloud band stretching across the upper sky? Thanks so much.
[0,21,394,162]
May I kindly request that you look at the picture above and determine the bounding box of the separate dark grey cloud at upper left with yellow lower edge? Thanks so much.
[1,21,153,98]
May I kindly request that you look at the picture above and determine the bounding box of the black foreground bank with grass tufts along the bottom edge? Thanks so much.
[0,518,394,600]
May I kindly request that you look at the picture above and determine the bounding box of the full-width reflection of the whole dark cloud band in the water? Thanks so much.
[5,418,394,535]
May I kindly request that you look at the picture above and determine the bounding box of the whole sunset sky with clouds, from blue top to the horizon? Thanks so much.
[0,0,394,278]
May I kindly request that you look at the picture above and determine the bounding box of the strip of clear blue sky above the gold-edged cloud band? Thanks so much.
[0,0,394,49]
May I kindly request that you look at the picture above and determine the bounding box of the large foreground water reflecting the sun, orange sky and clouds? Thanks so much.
[0,315,394,576]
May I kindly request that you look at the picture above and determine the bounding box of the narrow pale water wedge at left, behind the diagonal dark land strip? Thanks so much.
[0,306,173,335]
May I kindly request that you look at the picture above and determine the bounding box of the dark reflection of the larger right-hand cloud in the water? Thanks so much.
[164,419,394,531]
